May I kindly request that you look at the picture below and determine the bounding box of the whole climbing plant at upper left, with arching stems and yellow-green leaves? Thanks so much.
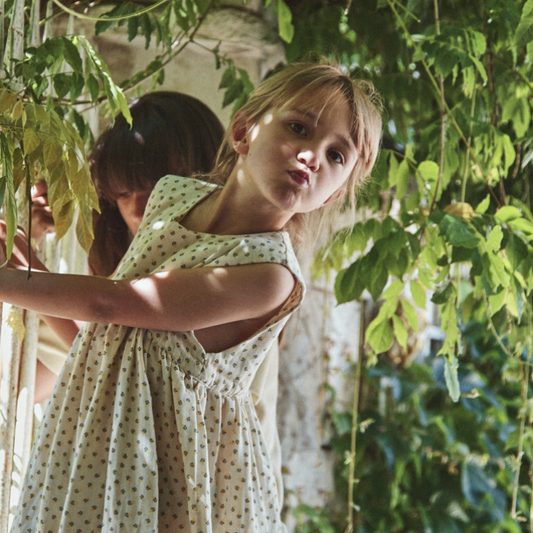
[0,0,293,253]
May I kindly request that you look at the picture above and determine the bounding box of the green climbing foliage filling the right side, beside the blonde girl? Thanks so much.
[280,0,533,531]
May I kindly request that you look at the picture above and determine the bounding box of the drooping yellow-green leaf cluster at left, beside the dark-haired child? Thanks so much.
[0,6,130,254]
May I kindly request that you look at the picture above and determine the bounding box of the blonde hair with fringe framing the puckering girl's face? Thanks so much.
[210,62,382,241]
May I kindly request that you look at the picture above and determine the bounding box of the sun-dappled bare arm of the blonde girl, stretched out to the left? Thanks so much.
[0,258,295,331]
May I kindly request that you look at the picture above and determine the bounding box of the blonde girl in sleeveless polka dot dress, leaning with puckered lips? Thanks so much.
[0,64,381,533]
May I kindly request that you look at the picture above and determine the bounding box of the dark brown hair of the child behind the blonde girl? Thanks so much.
[89,91,224,276]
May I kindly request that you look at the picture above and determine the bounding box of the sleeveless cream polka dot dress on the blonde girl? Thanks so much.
[12,176,304,533]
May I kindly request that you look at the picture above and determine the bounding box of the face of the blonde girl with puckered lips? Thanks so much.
[235,97,358,215]
